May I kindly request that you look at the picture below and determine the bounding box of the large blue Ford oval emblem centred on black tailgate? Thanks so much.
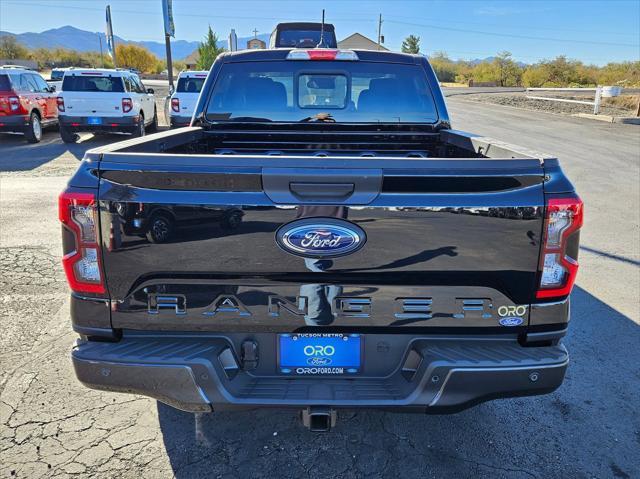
[276,218,367,258]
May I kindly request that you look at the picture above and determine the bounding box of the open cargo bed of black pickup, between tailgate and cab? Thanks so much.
[86,125,553,162]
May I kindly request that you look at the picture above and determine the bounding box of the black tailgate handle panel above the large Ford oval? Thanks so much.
[262,167,382,205]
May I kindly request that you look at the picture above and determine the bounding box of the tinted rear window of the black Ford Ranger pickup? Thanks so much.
[207,61,438,124]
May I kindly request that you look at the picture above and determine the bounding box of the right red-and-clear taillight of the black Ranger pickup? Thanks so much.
[536,197,583,298]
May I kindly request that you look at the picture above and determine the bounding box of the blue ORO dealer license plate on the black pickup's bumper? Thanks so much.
[278,333,363,376]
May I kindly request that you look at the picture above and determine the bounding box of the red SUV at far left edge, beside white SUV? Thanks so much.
[0,66,58,143]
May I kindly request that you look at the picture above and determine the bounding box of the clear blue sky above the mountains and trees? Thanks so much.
[0,0,640,64]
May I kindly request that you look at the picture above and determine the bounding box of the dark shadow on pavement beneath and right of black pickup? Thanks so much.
[158,288,640,478]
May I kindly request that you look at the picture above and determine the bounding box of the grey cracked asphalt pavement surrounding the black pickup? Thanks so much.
[0,96,640,479]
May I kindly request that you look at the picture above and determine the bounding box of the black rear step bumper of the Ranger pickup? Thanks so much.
[72,335,568,413]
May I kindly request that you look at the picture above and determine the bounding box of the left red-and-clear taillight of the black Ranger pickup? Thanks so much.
[58,191,105,293]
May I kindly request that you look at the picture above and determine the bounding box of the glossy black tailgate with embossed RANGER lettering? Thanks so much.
[99,153,544,332]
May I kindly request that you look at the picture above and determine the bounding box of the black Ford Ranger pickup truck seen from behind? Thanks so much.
[60,49,583,430]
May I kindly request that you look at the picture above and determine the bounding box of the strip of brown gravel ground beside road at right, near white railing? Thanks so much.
[465,92,633,116]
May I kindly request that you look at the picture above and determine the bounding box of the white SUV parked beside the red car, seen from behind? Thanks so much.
[58,68,158,143]
